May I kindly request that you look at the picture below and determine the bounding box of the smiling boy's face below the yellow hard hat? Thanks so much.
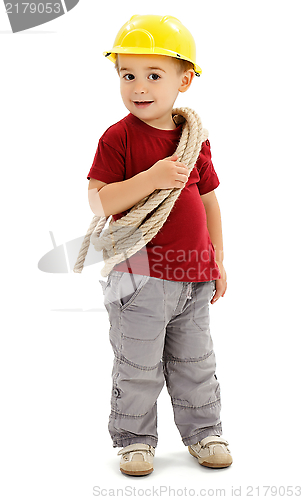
[118,54,194,129]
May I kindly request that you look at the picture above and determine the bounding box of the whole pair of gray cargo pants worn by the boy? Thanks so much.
[100,270,222,447]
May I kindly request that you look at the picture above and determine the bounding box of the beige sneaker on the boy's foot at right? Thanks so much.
[188,436,233,468]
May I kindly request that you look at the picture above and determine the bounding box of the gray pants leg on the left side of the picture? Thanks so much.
[104,271,169,447]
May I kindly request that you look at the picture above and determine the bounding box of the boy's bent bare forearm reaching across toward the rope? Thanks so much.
[88,170,155,217]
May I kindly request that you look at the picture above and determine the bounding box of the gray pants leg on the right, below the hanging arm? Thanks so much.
[163,282,222,446]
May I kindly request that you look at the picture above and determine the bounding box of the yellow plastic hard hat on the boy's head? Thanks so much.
[103,15,202,76]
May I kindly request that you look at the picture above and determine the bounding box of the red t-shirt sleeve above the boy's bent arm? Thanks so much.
[87,134,125,184]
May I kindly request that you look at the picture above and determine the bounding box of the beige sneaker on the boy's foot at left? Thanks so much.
[118,443,155,476]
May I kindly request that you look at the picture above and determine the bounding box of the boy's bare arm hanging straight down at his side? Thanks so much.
[201,191,227,303]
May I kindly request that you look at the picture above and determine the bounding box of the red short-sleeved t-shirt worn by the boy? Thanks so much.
[87,114,221,281]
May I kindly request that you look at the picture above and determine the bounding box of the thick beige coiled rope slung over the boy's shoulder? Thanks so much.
[74,108,208,276]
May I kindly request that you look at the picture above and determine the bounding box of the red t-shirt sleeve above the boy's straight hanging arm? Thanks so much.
[196,139,220,195]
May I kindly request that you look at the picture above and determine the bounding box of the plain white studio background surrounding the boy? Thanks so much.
[0,0,303,500]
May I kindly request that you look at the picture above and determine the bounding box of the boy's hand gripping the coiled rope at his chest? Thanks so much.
[148,154,189,189]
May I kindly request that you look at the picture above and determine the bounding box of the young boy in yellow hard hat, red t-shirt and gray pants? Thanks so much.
[87,16,232,475]
